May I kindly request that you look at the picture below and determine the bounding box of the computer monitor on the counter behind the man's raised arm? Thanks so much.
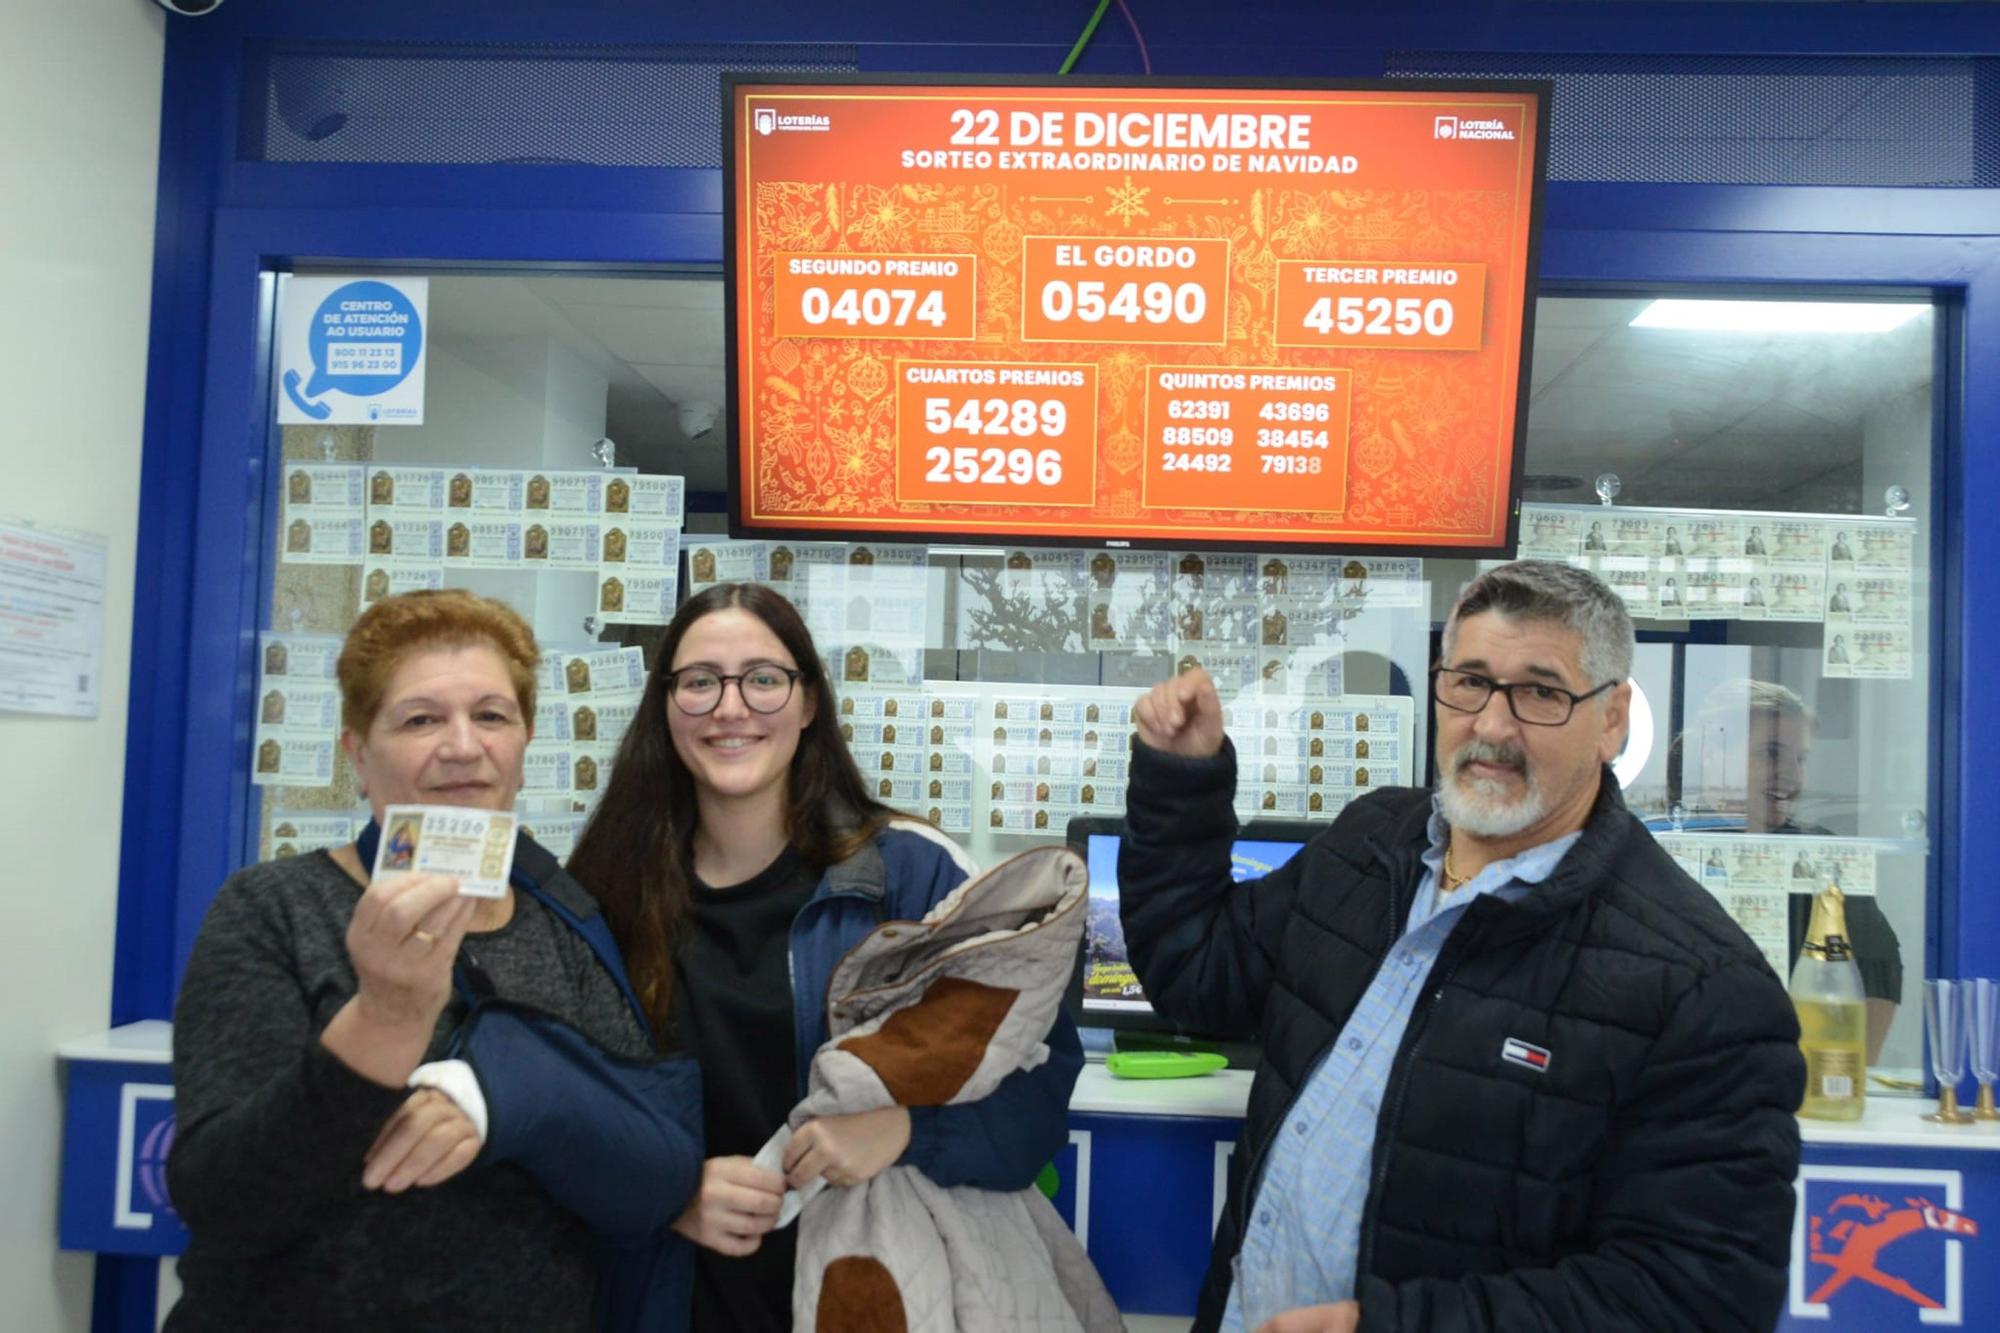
[1066,817,1326,1063]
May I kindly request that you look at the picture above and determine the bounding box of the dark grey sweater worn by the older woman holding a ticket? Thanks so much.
[166,853,650,1333]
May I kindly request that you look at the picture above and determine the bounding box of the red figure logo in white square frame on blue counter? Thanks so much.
[1792,1163,1980,1329]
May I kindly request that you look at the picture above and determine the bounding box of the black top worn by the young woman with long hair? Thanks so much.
[674,849,820,1333]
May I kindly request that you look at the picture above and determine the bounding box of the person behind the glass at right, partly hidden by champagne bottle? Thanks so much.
[1670,681,1902,1061]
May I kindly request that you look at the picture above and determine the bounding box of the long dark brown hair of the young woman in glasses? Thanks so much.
[570,582,894,1041]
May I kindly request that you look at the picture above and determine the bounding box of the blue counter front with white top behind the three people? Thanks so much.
[60,1023,2000,1333]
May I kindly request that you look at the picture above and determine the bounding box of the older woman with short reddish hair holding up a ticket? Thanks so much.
[168,590,700,1329]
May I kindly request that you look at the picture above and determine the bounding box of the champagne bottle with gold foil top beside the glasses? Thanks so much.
[1792,885,1868,1121]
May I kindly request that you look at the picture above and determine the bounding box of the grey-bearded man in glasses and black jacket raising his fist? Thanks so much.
[1118,560,1806,1333]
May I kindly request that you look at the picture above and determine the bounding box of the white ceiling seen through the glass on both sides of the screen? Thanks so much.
[432,274,1932,512]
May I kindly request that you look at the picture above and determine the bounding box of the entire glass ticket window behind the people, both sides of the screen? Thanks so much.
[252,274,1936,1077]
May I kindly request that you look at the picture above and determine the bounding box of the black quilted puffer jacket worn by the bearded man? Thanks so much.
[1118,745,1806,1333]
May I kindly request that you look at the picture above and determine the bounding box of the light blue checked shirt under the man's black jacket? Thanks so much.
[1222,799,1582,1333]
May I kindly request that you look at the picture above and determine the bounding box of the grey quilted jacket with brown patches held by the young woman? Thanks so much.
[780,847,1122,1333]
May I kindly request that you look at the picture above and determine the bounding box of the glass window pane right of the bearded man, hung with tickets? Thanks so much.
[1430,296,1936,1091]
